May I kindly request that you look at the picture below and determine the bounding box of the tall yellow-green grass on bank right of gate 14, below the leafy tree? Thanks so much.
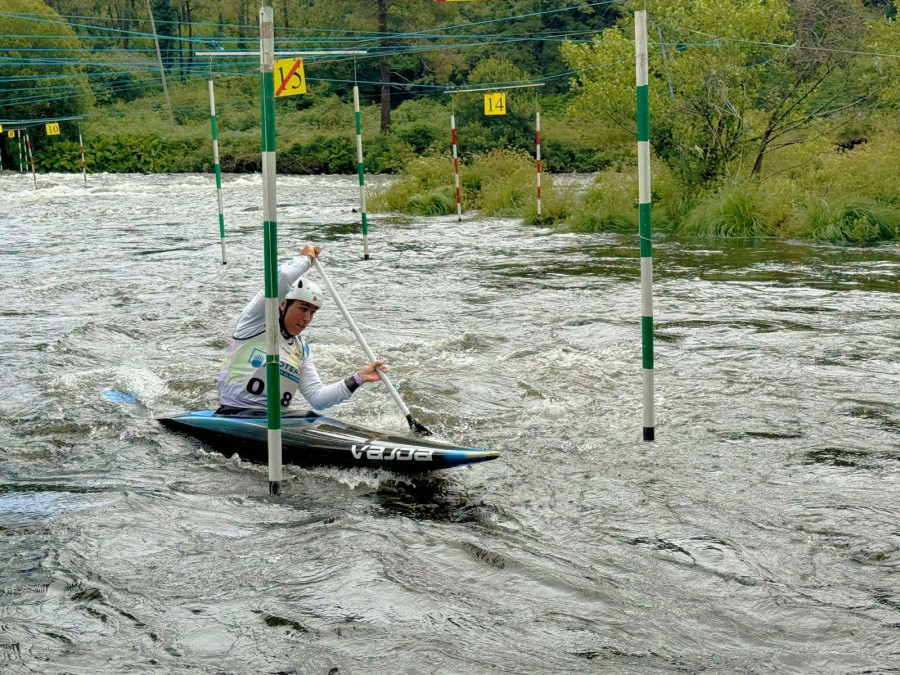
[556,129,900,244]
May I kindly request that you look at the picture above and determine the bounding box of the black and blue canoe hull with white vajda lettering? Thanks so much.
[157,410,500,473]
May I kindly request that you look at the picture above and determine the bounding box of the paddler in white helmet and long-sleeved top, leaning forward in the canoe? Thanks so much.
[216,244,386,415]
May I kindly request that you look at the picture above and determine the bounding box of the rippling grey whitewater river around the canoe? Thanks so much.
[0,172,900,675]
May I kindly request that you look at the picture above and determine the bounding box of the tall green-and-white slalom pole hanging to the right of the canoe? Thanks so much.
[634,10,656,441]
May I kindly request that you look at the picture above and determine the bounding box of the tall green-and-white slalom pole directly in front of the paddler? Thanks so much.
[259,7,281,495]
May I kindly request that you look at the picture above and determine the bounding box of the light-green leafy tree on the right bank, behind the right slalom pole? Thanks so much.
[562,0,873,182]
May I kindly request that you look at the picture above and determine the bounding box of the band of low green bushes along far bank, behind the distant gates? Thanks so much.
[10,77,622,174]
